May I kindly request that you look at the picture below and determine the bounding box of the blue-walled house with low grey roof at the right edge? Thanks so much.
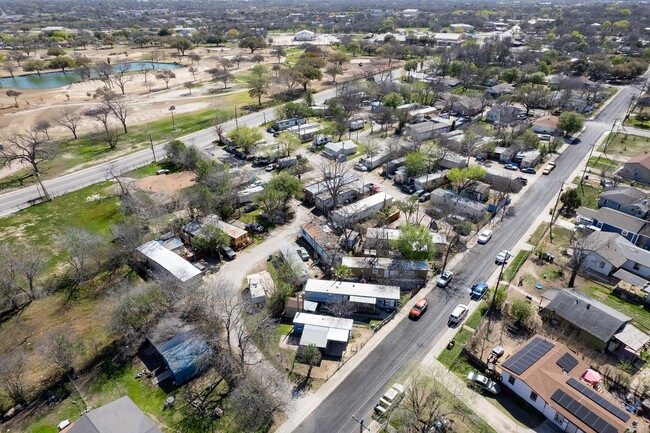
[576,207,650,249]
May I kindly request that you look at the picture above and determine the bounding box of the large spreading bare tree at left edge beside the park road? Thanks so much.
[0,127,57,201]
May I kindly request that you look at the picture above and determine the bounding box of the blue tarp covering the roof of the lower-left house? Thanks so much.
[156,331,210,385]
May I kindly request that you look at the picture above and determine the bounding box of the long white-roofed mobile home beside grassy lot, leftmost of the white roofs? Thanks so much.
[137,241,203,287]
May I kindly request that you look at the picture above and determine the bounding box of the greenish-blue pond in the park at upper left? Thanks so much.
[0,62,181,89]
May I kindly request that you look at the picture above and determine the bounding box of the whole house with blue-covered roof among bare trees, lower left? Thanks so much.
[146,330,212,386]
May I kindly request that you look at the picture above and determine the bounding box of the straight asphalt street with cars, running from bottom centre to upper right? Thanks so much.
[294,78,636,433]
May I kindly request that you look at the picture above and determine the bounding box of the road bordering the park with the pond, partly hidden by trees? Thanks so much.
[0,69,402,216]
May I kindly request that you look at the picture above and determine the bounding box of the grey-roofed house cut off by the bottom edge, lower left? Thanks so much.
[65,396,162,433]
